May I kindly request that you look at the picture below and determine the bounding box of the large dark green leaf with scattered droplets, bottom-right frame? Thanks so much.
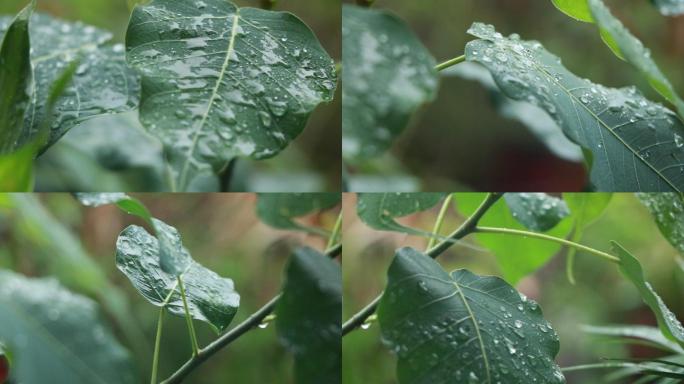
[378,248,565,384]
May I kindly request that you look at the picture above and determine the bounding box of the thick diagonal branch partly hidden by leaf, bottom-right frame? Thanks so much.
[342,193,503,336]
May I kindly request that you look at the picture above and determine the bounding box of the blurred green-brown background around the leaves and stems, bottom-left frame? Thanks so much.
[0,194,339,384]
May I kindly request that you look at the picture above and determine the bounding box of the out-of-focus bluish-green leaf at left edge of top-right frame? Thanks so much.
[342,5,438,161]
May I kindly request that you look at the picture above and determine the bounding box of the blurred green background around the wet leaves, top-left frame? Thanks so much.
[0,0,342,192]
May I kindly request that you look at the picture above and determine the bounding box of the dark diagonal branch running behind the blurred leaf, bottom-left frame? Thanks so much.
[162,244,342,384]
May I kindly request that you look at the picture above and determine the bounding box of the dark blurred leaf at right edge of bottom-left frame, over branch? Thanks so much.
[275,247,342,384]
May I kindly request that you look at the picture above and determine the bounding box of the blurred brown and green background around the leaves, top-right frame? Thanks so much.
[344,0,684,191]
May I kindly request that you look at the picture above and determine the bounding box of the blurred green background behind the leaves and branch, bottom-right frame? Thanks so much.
[342,194,684,384]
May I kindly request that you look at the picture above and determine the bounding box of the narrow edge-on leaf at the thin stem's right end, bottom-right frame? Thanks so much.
[611,241,684,346]
